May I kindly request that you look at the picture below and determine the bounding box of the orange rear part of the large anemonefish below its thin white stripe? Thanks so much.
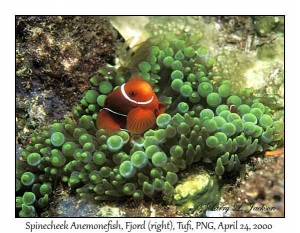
[97,109,120,135]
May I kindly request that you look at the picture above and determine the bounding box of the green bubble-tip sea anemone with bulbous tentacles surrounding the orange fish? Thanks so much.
[16,34,284,216]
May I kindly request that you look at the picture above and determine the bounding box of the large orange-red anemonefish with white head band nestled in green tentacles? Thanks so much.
[97,77,166,135]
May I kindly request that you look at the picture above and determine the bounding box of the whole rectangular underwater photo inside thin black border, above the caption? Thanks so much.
[15,16,285,217]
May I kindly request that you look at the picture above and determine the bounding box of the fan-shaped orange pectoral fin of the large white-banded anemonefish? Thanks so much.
[126,107,156,134]
